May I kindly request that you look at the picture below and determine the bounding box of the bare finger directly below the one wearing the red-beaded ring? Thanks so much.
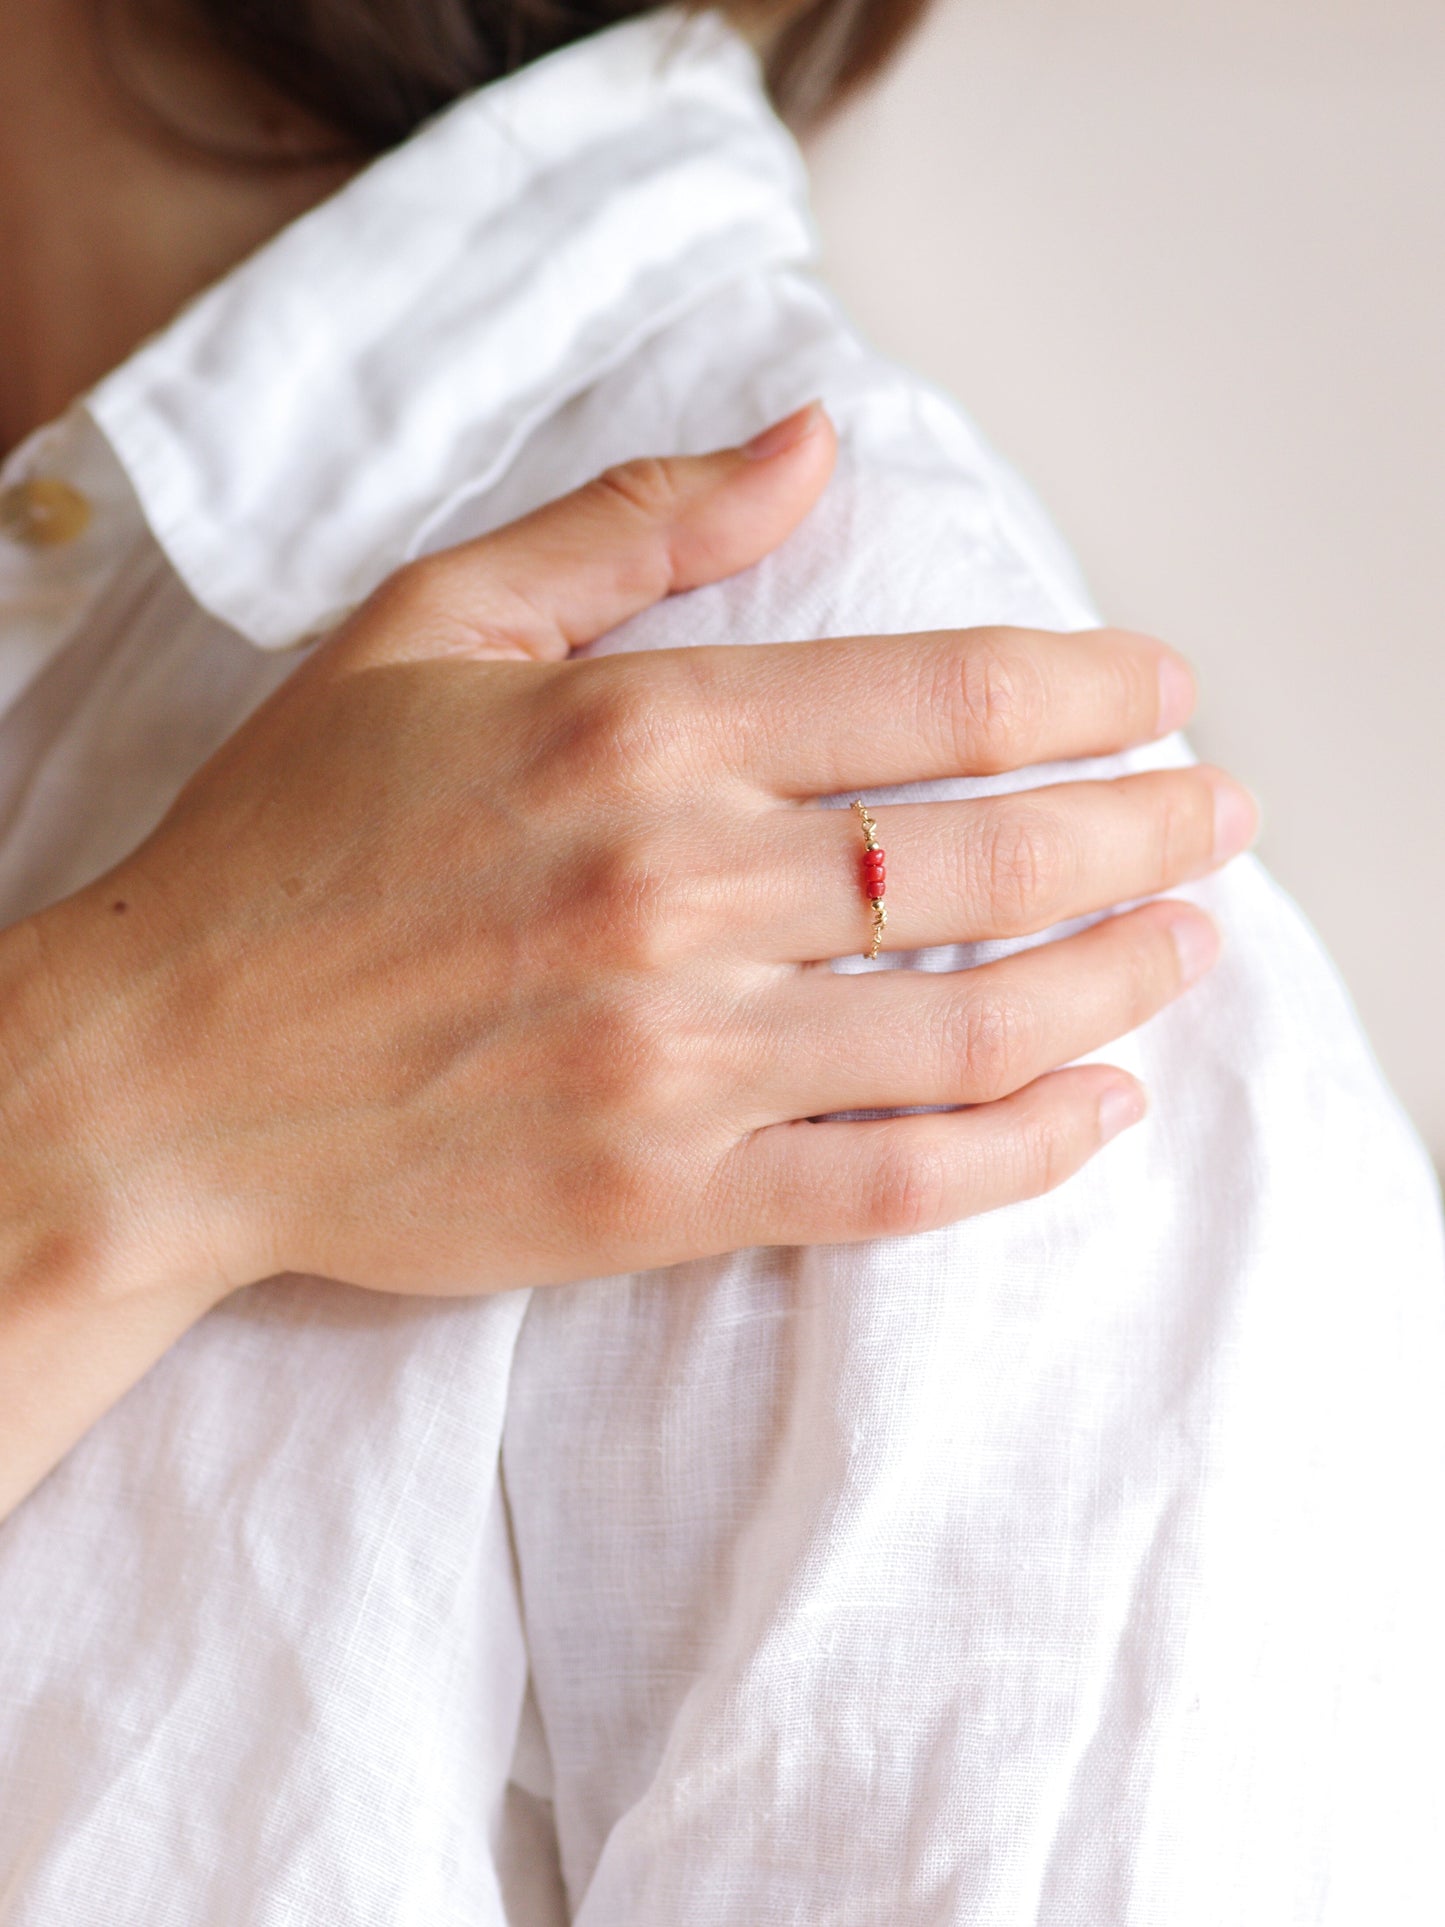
[759,902,1220,1118]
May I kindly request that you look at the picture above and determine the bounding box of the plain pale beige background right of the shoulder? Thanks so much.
[811,0,1445,1168]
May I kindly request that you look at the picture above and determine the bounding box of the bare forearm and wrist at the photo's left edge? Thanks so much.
[0,904,225,1518]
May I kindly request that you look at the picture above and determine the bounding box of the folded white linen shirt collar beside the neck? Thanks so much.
[87,10,813,649]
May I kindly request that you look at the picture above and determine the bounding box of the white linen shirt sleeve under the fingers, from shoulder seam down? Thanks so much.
[503,358,1445,1927]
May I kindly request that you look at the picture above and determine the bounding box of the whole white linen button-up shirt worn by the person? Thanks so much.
[0,13,1445,1927]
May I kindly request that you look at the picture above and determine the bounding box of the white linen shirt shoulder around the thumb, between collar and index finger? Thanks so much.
[418,268,1096,647]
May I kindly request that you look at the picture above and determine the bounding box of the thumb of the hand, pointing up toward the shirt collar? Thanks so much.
[337,403,836,663]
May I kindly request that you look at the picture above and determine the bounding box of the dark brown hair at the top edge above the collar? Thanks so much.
[147,0,929,154]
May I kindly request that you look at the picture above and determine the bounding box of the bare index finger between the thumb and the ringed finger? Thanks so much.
[651,628,1195,796]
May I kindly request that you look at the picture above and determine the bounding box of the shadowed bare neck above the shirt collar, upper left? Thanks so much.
[0,0,351,455]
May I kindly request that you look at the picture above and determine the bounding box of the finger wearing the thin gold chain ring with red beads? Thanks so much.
[747,765,1258,962]
